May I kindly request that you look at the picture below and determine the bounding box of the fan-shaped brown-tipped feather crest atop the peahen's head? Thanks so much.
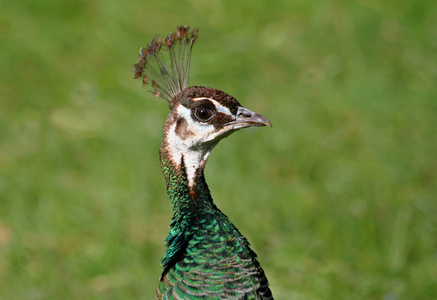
[134,26,199,109]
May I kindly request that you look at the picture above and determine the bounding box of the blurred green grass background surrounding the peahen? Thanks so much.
[0,0,437,300]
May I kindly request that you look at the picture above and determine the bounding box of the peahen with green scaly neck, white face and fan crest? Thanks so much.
[134,26,273,299]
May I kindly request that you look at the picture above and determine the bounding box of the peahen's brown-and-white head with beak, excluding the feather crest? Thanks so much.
[163,87,272,179]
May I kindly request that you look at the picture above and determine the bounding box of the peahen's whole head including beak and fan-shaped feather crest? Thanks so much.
[134,26,271,180]
